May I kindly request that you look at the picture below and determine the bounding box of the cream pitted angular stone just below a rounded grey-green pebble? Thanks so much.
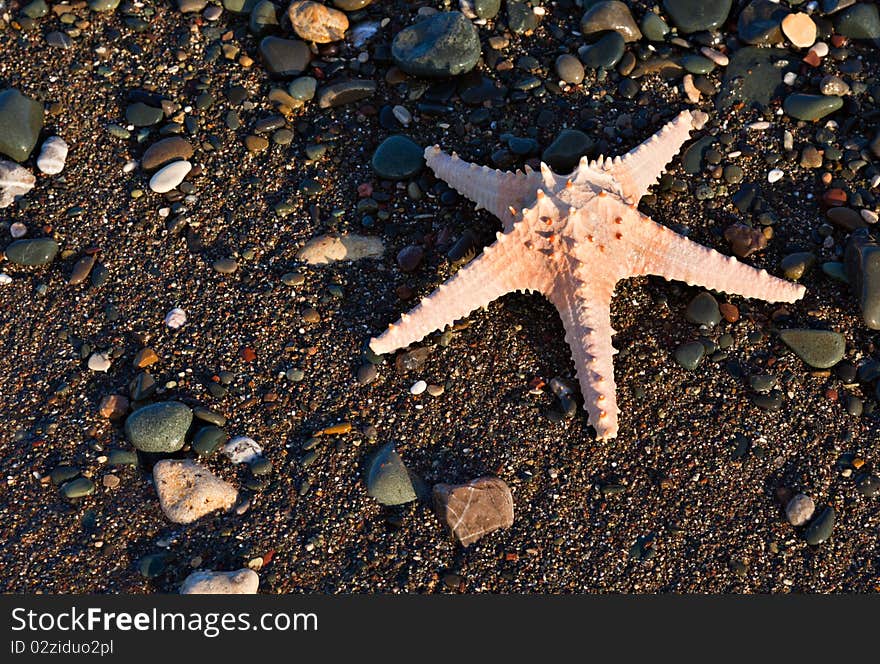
[153,459,238,524]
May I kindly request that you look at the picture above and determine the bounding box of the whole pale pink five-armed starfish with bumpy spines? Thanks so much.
[370,111,804,439]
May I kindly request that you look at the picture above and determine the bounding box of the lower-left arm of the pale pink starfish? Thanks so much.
[370,226,548,355]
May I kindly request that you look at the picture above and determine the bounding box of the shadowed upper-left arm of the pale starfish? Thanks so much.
[425,145,542,231]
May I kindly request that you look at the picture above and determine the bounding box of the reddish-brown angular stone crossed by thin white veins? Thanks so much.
[432,477,513,547]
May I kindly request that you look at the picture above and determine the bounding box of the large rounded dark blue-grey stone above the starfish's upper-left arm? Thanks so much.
[391,9,482,78]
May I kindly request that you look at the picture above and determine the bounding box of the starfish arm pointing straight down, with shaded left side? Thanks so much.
[549,278,618,440]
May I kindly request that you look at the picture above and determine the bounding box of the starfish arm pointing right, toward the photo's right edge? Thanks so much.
[631,217,806,302]
